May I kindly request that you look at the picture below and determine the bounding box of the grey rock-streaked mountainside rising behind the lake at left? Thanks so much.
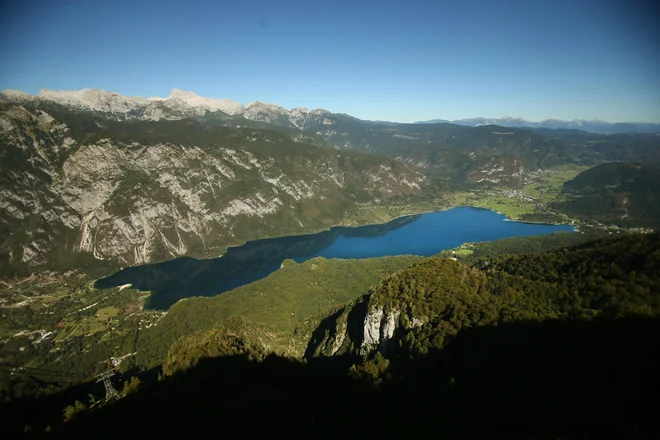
[0,105,427,274]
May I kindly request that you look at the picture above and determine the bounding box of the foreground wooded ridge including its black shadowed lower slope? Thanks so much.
[2,234,660,438]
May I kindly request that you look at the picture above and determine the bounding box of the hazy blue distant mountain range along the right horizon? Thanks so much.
[415,116,660,134]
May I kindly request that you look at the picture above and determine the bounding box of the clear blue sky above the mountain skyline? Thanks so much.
[0,0,660,122]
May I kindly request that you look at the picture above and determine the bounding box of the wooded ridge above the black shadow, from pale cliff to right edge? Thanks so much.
[310,234,660,357]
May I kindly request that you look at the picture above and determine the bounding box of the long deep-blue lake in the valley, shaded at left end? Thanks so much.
[95,208,574,310]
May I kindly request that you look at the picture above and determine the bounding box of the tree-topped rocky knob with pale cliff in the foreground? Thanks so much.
[315,258,486,356]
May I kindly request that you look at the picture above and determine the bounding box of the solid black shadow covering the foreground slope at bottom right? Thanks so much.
[3,319,660,439]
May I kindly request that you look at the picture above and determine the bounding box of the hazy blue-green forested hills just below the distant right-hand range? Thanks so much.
[276,114,660,180]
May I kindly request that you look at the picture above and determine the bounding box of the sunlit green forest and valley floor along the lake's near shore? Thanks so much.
[0,256,422,402]
